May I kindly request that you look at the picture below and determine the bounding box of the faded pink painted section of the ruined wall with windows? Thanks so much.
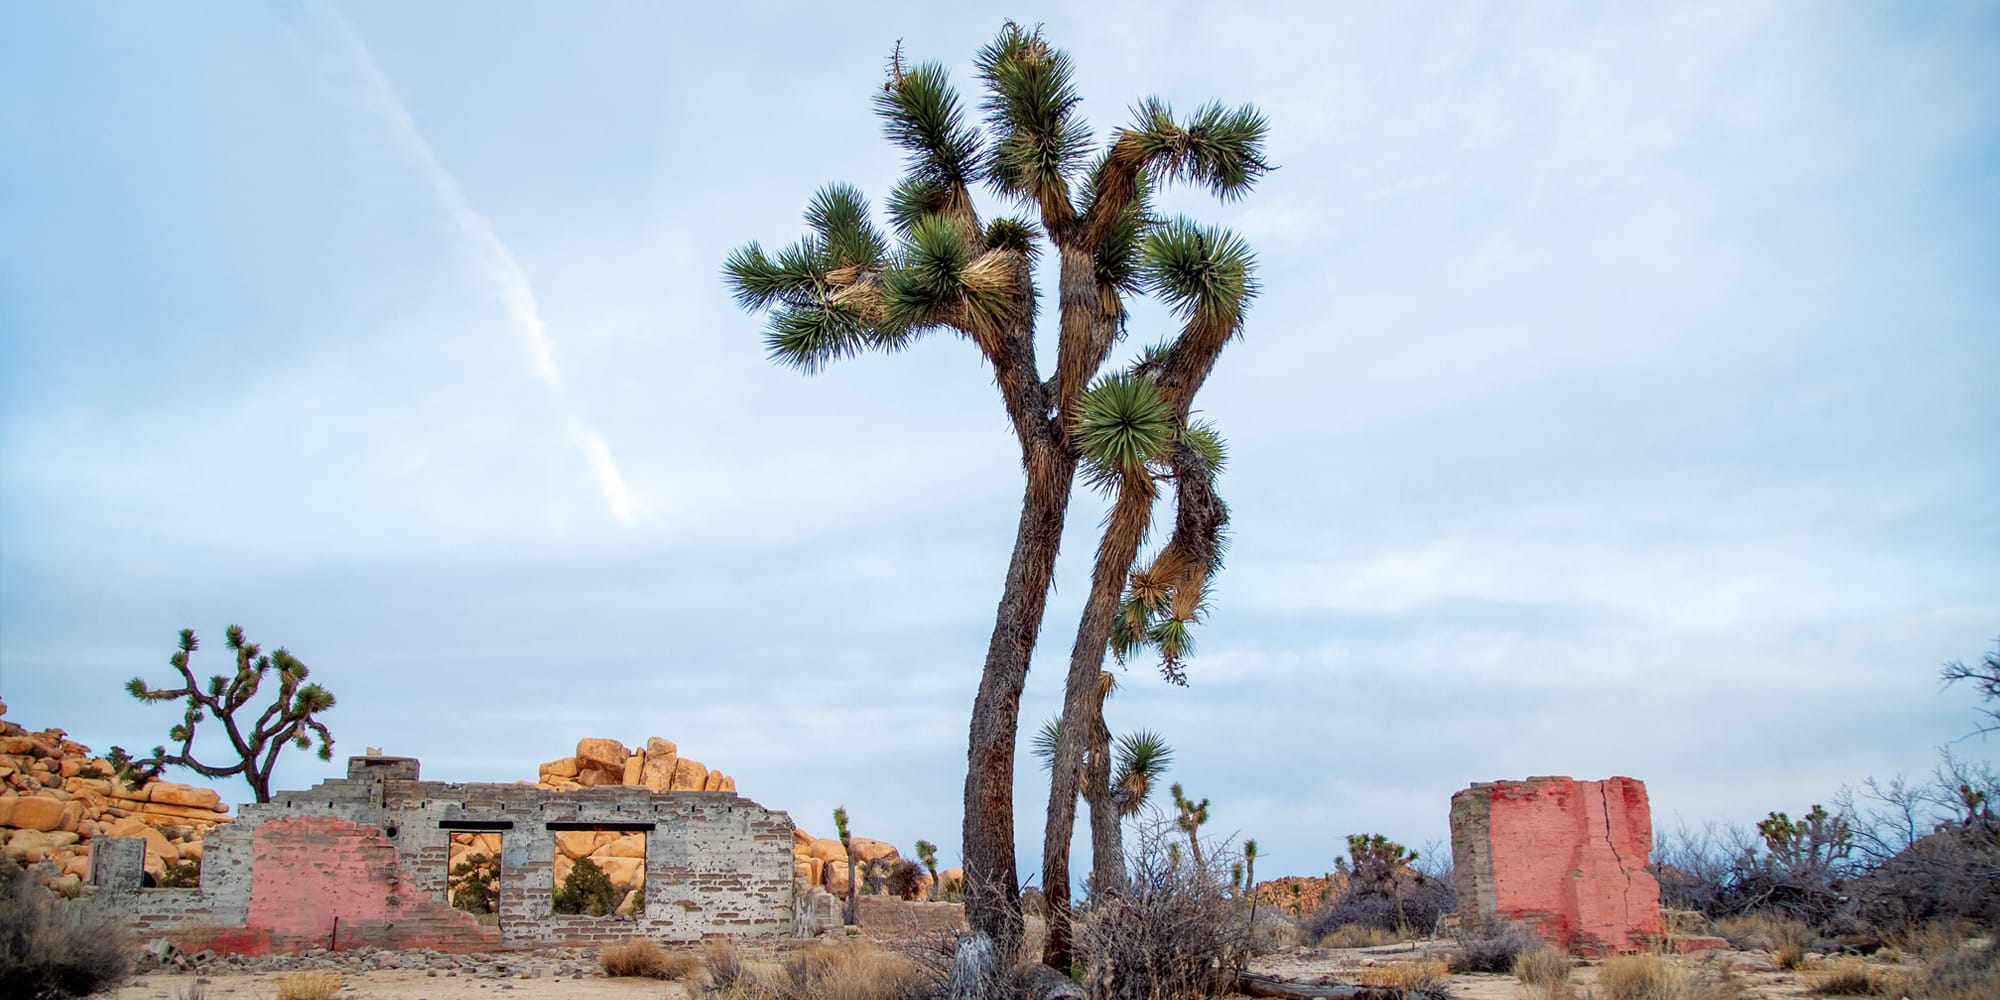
[248,816,500,950]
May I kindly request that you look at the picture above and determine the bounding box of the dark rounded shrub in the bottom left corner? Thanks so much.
[0,864,132,1000]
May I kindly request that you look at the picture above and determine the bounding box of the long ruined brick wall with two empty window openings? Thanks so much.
[94,758,792,954]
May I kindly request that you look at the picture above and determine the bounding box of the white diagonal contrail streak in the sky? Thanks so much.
[312,0,642,524]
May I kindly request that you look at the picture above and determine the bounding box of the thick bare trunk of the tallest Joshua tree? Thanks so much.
[962,436,1076,954]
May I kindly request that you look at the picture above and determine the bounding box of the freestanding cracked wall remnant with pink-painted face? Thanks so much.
[1452,778,1664,954]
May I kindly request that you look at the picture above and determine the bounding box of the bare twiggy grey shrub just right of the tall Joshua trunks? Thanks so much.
[1076,814,1248,1000]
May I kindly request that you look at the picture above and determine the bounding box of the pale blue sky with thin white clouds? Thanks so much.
[0,0,2000,880]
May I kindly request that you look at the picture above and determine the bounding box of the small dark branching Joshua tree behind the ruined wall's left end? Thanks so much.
[110,626,334,802]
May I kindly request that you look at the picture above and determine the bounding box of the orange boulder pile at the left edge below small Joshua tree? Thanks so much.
[0,702,230,894]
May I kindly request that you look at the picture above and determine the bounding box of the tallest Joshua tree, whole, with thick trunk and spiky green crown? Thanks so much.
[724,24,1268,954]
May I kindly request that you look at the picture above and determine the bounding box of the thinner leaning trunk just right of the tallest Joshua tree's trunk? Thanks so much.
[1042,472,1154,970]
